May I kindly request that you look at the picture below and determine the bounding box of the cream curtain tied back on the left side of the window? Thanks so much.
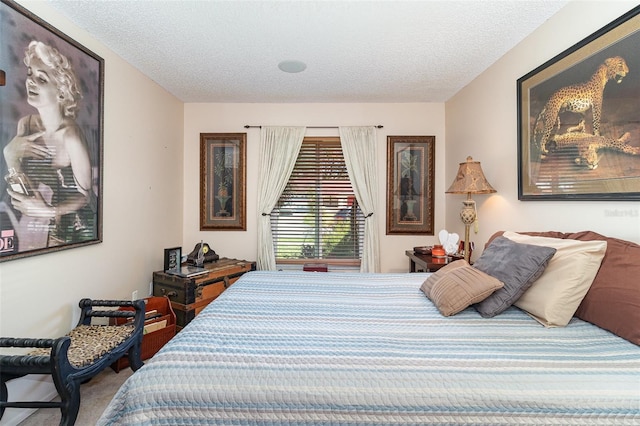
[256,127,306,271]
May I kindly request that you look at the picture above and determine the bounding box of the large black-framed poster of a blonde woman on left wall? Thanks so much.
[0,0,104,261]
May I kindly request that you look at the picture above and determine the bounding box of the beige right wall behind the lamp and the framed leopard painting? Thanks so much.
[446,1,640,257]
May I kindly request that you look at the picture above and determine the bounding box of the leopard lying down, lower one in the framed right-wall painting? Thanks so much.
[549,125,640,170]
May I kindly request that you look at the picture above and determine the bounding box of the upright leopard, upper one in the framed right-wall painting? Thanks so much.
[534,56,629,159]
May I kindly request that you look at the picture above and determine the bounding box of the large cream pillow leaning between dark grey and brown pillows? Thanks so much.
[503,231,607,327]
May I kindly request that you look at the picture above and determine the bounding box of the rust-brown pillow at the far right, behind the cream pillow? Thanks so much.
[569,231,640,345]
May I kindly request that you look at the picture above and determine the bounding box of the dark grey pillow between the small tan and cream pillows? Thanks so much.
[473,237,556,318]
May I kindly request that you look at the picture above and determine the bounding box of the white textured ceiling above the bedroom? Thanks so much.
[48,0,568,103]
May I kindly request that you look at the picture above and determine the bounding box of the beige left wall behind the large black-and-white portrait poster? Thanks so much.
[0,2,183,337]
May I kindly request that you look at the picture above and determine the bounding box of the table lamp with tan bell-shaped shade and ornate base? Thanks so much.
[446,157,496,262]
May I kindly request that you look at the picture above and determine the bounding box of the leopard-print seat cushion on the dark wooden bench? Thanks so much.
[29,324,134,368]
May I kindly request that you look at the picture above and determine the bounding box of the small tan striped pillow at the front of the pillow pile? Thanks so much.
[420,260,503,317]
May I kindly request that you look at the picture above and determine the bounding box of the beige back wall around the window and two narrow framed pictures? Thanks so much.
[183,103,445,272]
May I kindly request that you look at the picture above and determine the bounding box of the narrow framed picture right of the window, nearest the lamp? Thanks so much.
[387,136,436,235]
